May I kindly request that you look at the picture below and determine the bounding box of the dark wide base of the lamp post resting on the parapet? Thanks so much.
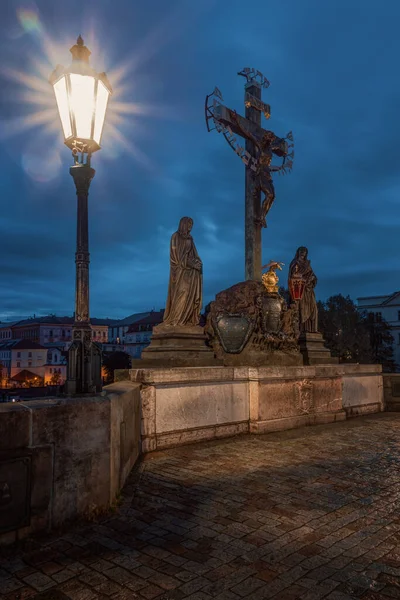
[65,325,102,396]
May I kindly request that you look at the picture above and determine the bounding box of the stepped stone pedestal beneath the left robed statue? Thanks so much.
[137,323,221,368]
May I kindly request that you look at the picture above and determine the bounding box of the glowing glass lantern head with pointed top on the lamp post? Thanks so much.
[50,36,112,153]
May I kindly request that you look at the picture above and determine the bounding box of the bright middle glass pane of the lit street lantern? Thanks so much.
[70,73,95,140]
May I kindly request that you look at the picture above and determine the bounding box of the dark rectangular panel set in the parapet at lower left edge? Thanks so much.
[0,456,31,533]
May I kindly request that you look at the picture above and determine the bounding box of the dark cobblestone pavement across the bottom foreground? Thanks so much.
[0,413,400,600]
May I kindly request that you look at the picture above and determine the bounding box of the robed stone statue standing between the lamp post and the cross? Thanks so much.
[163,217,203,326]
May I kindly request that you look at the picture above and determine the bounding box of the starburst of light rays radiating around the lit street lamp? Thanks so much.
[0,0,216,183]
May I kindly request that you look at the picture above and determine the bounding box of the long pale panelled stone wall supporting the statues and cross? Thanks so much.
[129,365,383,452]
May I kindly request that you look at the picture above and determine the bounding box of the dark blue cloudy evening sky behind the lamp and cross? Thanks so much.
[0,0,400,318]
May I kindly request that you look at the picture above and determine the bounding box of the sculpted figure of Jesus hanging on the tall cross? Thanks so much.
[229,110,288,227]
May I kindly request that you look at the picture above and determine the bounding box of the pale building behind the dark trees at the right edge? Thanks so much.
[357,292,400,365]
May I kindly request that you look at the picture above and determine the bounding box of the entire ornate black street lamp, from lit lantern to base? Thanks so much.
[50,36,112,394]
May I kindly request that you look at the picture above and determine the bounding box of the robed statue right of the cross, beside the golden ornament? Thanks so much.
[289,246,318,333]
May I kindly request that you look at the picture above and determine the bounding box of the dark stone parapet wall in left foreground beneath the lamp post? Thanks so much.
[0,381,140,543]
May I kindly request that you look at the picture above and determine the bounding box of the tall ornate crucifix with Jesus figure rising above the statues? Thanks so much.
[205,68,294,281]
